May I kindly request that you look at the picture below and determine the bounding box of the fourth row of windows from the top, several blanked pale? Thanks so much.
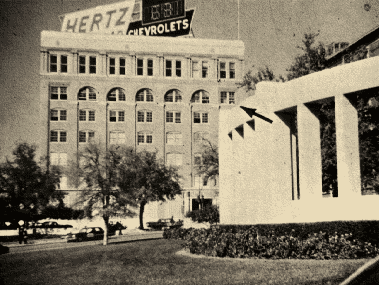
[50,130,208,145]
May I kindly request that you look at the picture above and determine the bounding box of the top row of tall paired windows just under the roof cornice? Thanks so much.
[49,54,236,79]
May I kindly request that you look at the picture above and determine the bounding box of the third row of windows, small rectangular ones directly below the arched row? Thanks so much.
[50,109,209,124]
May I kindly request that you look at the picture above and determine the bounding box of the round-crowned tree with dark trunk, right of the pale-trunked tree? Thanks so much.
[119,151,182,229]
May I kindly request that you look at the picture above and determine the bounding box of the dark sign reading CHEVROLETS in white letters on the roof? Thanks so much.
[128,9,195,37]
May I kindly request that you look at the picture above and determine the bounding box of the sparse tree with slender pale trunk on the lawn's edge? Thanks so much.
[67,144,137,245]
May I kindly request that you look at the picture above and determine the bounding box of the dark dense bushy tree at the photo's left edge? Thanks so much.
[0,143,64,224]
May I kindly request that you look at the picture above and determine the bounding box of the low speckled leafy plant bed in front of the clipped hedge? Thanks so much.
[163,226,379,259]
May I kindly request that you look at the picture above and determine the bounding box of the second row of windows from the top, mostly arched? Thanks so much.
[50,86,235,104]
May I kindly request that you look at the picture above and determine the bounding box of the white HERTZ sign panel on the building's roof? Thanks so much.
[60,0,135,35]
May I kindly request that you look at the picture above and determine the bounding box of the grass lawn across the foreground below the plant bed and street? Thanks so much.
[0,239,367,284]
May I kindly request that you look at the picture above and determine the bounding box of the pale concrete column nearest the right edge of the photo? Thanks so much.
[335,94,361,197]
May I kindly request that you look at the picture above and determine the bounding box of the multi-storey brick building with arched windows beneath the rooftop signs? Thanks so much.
[40,1,244,222]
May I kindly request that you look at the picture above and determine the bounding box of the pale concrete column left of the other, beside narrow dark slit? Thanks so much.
[297,104,322,200]
